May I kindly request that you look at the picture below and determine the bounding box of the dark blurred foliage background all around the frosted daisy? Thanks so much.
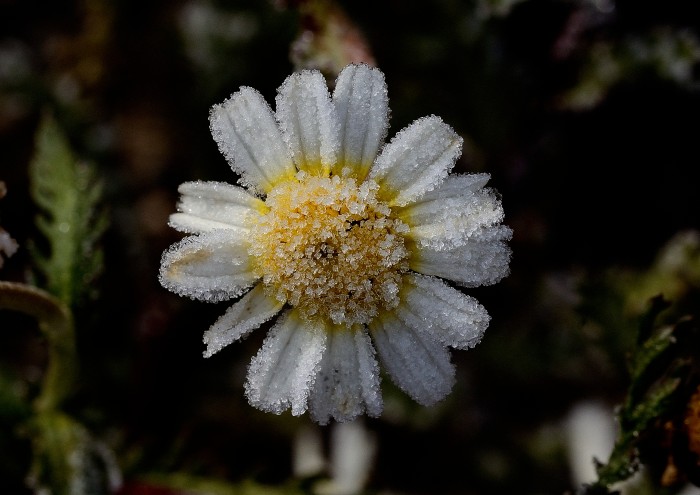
[0,0,700,495]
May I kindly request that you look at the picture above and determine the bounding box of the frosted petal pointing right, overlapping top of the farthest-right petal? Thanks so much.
[396,174,504,249]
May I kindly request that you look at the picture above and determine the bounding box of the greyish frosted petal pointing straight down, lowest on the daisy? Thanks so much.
[309,326,382,424]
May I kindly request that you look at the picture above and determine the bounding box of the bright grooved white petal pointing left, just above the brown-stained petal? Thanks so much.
[170,181,267,234]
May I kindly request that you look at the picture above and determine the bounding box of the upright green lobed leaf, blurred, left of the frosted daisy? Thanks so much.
[29,116,107,306]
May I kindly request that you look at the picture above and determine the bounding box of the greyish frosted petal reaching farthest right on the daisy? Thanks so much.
[410,225,512,287]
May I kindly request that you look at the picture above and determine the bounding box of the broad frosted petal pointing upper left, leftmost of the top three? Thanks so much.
[209,87,296,192]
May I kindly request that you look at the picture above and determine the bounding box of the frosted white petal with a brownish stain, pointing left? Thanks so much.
[159,230,257,302]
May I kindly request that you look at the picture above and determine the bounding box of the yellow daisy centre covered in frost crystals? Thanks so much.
[250,172,408,326]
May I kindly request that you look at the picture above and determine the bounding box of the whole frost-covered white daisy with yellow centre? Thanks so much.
[160,65,511,424]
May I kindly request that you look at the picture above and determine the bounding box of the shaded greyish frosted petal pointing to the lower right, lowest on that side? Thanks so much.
[370,315,455,406]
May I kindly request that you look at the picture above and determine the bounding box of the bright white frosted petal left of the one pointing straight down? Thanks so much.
[245,311,326,416]
